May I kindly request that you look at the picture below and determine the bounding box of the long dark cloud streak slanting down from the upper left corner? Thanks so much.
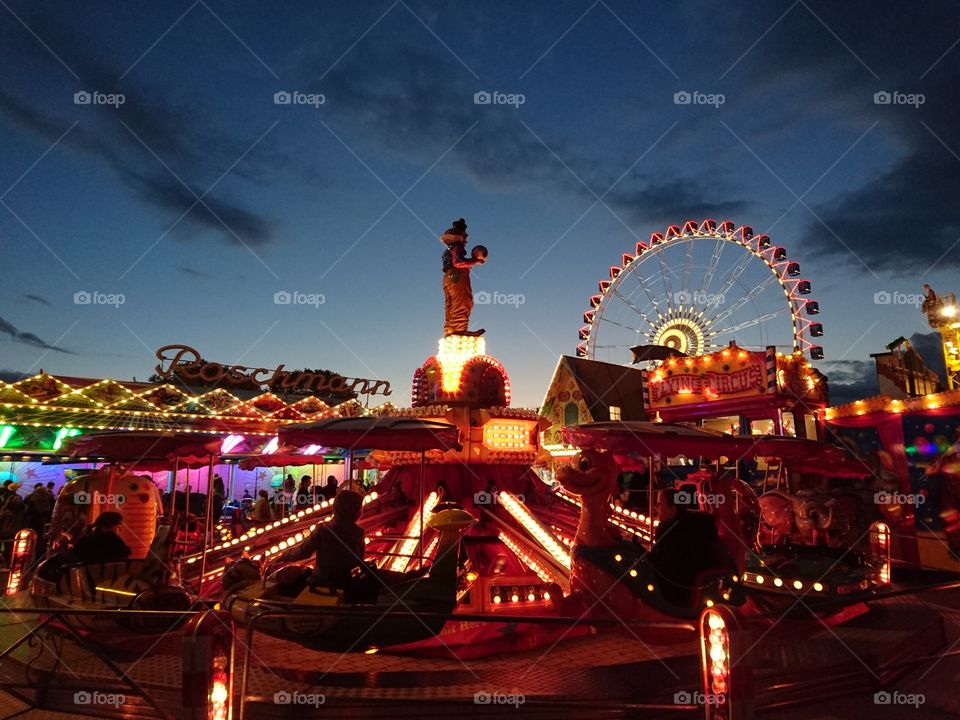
[0,11,282,248]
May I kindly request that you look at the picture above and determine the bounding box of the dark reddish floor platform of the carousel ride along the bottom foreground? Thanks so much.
[0,597,952,718]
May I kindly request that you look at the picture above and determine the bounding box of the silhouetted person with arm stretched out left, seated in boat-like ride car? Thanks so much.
[276,490,367,590]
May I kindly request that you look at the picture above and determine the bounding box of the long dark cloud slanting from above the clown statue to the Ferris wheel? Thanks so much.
[314,38,748,231]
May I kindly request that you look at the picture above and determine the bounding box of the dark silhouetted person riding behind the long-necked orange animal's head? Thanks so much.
[650,489,717,606]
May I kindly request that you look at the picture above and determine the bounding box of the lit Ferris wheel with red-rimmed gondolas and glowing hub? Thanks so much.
[577,220,823,363]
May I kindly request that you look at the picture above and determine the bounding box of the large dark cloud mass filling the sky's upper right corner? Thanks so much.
[712,0,960,274]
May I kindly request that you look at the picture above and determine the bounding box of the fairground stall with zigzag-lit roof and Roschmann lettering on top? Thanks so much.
[0,346,392,496]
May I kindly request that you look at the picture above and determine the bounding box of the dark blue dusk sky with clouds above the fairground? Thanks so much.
[0,0,960,406]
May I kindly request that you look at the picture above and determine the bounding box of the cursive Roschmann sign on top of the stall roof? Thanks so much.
[156,345,391,398]
